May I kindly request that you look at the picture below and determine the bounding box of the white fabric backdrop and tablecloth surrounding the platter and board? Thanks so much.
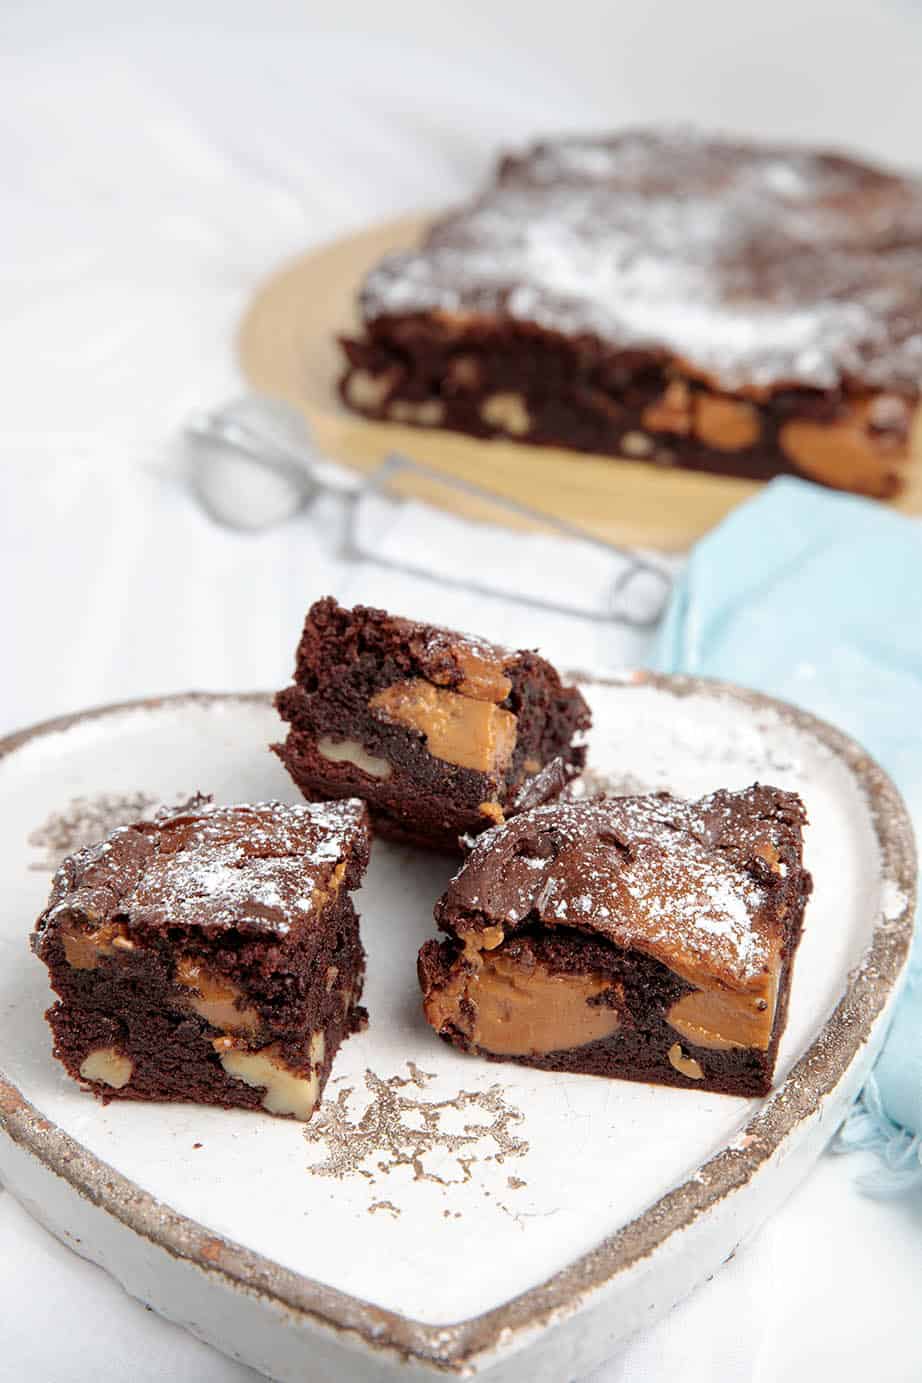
[0,0,922,1383]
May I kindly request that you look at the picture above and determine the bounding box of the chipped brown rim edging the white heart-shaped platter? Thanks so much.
[0,685,916,1376]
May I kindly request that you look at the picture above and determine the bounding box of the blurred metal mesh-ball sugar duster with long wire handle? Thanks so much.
[185,394,675,629]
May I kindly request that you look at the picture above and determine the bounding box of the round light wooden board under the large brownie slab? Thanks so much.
[238,216,922,550]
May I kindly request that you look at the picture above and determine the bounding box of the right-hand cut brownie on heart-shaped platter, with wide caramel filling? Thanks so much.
[419,786,810,1095]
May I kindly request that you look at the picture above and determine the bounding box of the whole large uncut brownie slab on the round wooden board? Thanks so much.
[341,131,922,496]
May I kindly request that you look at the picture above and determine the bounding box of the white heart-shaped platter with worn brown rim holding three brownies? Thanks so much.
[0,678,915,1383]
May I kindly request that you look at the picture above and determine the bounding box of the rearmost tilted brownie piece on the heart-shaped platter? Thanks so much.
[274,596,590,849]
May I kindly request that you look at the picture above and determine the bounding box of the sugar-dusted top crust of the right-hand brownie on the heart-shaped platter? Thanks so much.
[452,787,802,987]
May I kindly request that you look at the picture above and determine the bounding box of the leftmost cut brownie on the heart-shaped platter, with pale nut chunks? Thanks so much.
[32,799,370,1119]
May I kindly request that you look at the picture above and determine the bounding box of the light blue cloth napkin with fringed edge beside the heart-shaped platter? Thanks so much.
[652,479,922,1194]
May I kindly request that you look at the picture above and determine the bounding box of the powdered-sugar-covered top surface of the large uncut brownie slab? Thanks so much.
[362,133,922,393]
